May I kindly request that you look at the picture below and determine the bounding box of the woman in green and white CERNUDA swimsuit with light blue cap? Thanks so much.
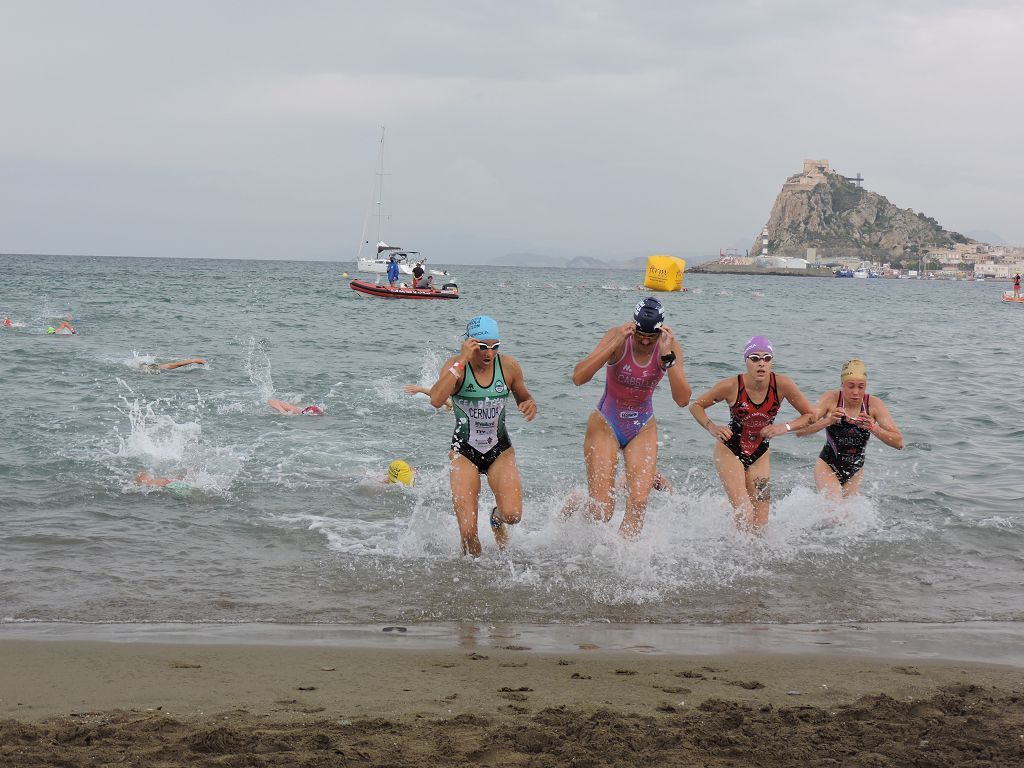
[430,314,537,557]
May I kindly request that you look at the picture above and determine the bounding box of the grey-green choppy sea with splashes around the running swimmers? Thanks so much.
[0,256,1024,627]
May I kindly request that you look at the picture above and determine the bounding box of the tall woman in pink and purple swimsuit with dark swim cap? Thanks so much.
[562,297,692,539]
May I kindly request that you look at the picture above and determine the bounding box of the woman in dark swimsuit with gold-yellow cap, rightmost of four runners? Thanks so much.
[797,357,903,499]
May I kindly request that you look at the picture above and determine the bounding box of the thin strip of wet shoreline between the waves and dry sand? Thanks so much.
[0,622,1024,669]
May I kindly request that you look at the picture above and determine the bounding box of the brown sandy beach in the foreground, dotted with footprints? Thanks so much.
[0,639,1024,767]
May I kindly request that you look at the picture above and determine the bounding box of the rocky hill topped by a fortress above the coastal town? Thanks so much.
[751,161,971,260]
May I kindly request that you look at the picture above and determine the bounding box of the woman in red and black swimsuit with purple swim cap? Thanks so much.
[690,336,817,531]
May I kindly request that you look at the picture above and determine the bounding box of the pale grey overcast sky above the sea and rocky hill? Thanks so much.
[0,0,1024,264]
